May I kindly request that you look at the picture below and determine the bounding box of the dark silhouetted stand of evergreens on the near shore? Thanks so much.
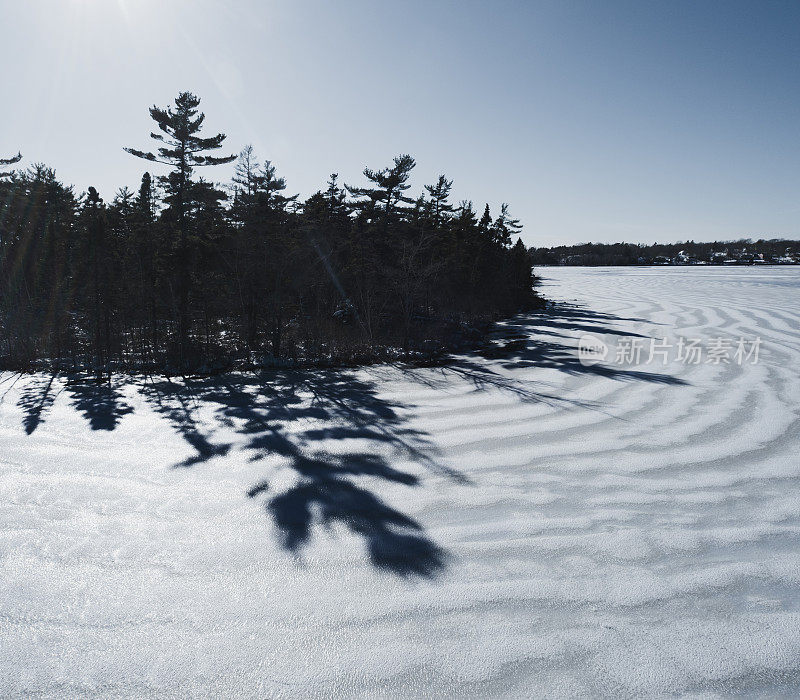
[0,93,537,372]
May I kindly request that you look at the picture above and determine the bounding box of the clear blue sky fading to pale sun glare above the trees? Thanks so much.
[0,0,800,245]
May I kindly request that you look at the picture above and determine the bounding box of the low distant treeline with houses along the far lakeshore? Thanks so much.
[530,238,800,266]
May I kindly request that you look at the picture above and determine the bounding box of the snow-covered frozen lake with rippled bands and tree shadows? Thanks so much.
[0,267,800,698]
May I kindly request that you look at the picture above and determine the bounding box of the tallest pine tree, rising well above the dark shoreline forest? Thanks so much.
[125,92,236,364]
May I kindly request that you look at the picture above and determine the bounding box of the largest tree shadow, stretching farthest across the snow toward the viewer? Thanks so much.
[141,370,456,577]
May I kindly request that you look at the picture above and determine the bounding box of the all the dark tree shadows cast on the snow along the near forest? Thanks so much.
[12,305,685,577]
